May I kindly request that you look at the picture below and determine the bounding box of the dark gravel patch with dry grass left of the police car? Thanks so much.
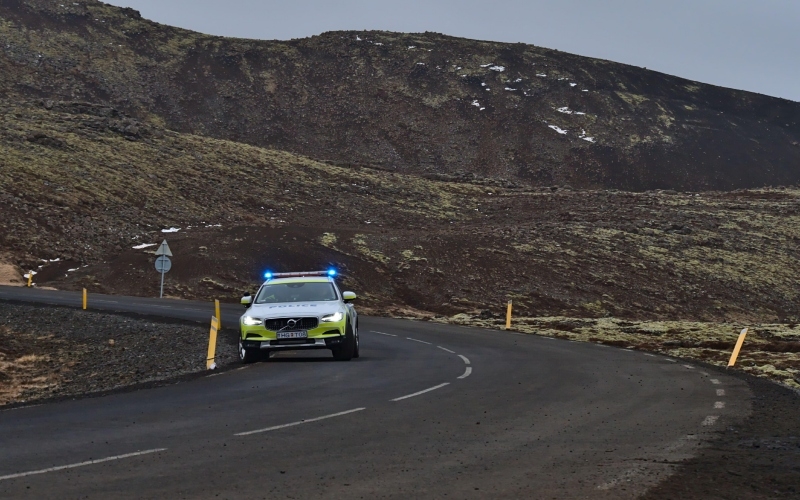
[0,303,238,405]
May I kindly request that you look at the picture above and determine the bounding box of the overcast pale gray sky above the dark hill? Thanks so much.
[109,0,800,101]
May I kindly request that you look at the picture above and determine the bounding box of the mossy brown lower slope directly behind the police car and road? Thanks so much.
[0,100,800,323]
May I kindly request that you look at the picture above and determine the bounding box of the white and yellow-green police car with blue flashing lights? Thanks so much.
[239,270,359,363]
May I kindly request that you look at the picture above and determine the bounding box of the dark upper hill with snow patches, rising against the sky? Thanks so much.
[0,0,800,191]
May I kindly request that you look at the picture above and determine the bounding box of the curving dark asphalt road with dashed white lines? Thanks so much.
[0,287,750,498]
